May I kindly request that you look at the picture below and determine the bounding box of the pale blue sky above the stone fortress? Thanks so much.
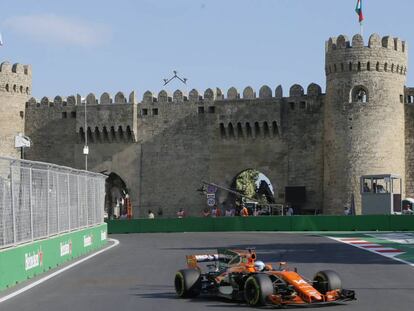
[0,0,414,99]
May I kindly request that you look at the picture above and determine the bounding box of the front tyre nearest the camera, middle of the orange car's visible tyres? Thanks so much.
[244,274,273,306]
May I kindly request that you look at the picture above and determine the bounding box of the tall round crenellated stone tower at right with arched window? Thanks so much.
[324,34,408,214]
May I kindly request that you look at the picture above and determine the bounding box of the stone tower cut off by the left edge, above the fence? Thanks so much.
[0,62,32,158]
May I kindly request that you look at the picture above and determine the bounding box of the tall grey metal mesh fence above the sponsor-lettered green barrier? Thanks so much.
[0,157,106,248]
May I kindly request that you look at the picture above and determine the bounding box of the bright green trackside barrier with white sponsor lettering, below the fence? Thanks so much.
[0,224,108,291]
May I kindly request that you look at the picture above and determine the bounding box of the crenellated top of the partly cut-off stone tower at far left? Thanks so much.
[0,62,32,96]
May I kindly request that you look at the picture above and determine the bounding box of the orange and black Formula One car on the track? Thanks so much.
[174,249,355,307]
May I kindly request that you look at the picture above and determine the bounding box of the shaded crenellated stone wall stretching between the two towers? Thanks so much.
[22,84,323,216]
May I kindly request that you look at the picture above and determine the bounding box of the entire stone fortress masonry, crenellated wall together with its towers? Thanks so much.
[0,34,414,217]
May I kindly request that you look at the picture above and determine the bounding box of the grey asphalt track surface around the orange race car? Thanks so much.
[0,232,414,311]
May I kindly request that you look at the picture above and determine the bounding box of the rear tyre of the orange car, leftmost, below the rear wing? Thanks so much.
[174,269,201,298]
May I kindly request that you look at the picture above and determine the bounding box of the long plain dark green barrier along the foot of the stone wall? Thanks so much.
[107,215,414,233]
